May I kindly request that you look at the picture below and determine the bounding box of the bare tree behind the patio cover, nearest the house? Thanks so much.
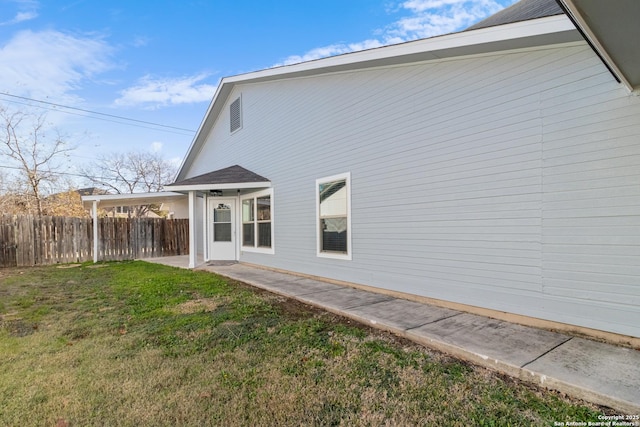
[82,151,177,216]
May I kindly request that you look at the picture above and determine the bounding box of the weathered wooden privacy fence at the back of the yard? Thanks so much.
[0,215,189,267]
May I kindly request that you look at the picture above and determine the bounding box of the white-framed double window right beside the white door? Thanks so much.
[241,189,274,253]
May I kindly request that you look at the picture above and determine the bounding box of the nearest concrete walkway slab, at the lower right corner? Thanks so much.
[526,338,640,414]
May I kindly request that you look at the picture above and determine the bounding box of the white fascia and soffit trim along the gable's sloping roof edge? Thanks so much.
[176,9,582,181]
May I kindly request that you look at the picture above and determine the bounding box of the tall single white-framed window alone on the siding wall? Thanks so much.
[316,173,351,259]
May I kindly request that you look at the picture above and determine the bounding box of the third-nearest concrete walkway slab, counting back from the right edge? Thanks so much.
[350,299,460,332]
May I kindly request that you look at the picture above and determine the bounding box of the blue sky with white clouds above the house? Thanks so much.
[0,0,516,186]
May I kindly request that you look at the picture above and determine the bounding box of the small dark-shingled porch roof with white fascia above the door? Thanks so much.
[165,165,271,191]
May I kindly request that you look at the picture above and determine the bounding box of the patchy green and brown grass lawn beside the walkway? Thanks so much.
[0,262,602,427]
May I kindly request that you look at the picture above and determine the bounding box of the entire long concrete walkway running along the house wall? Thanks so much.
[147,259,640,414]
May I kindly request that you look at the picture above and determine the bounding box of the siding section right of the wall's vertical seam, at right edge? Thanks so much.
[541,61,640,336]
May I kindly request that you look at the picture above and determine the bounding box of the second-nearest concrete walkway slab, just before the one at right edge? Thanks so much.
[407,313,569,368]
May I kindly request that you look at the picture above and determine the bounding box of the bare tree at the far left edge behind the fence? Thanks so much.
[0,106,73,215]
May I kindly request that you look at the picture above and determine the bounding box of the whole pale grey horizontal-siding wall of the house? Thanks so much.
[189,45,640,336]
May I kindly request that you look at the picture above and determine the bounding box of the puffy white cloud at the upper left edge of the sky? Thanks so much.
[0,30,112,103]
